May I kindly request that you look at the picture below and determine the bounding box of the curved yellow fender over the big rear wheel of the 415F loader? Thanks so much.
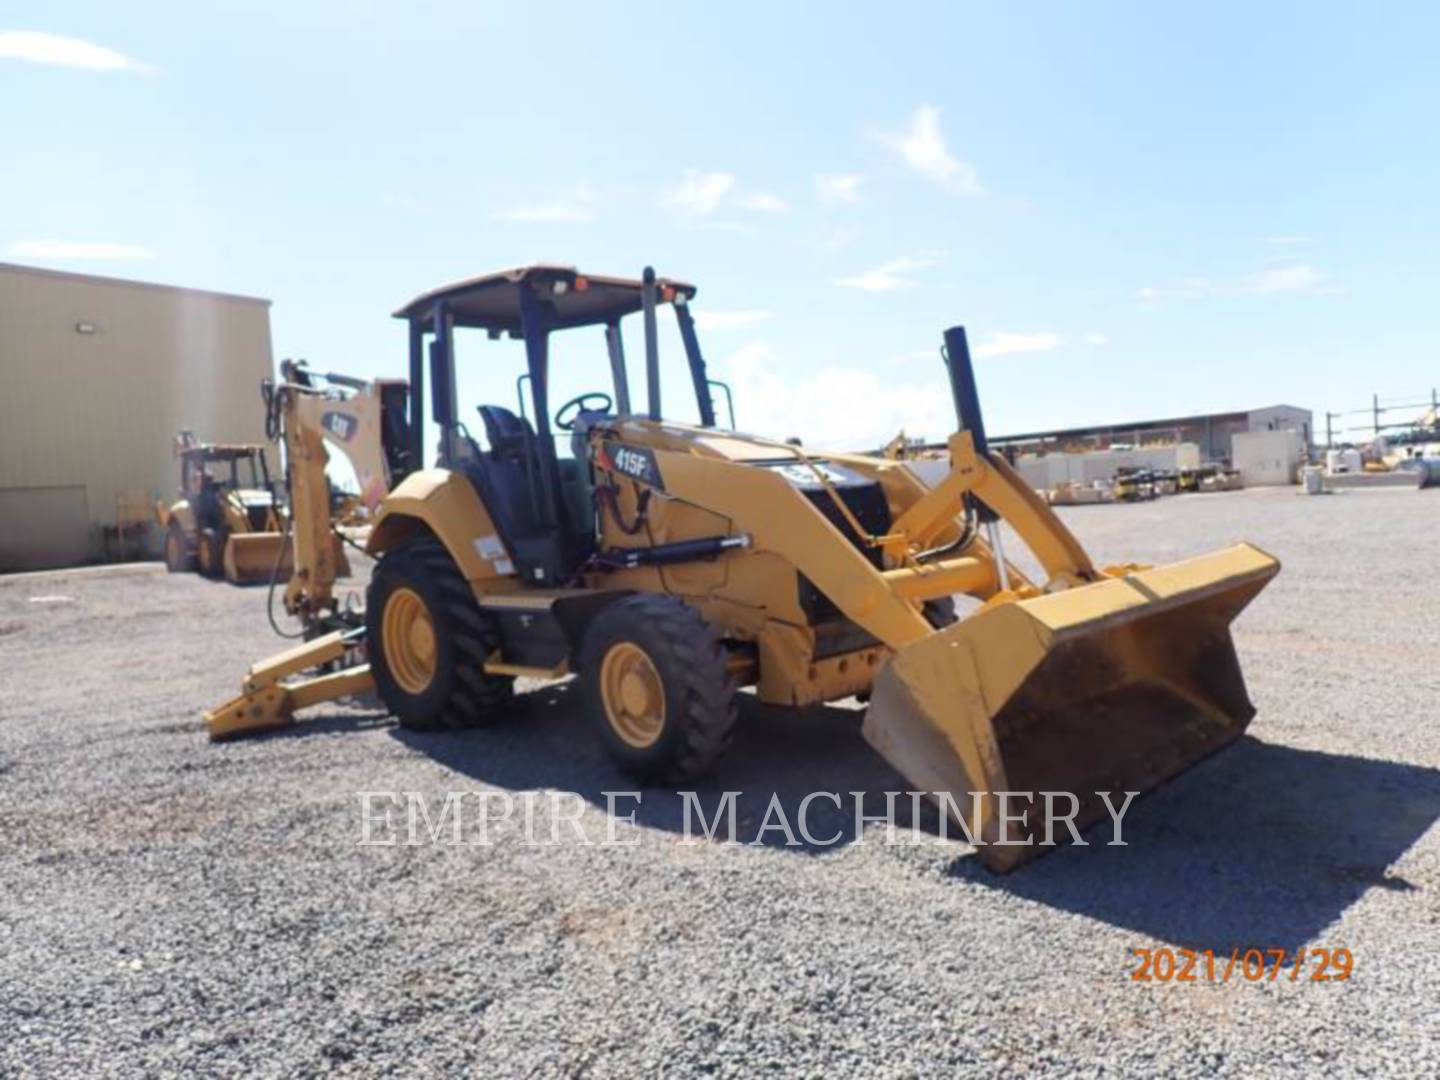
[364,469,516,595]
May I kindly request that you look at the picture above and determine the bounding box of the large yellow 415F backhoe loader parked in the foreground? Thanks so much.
[206,265,1279,870]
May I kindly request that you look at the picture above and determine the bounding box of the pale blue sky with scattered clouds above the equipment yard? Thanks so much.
[0,0,1440,445]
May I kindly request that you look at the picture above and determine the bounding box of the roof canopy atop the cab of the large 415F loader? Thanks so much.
[395,264,696,337]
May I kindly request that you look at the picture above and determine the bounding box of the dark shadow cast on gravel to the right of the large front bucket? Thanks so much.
[950,736,1440,953]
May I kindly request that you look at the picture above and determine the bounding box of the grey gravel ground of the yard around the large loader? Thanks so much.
[0,491,1440,1076]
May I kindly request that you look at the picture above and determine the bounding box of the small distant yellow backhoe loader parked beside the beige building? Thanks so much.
[156,431,289,583]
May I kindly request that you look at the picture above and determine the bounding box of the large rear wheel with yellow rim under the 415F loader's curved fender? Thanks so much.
[366,539,514,732]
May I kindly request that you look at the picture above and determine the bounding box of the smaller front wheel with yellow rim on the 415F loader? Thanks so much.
[580,595,737,783]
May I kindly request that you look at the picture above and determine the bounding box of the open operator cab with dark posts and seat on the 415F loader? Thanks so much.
[395,265,733,586]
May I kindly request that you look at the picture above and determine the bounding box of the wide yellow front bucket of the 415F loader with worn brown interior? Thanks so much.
[864,544,1280,871]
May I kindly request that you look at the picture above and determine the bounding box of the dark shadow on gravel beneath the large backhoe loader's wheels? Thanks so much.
[393,681,939,854]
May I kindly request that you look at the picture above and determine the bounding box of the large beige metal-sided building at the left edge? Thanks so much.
[0,264,272,572]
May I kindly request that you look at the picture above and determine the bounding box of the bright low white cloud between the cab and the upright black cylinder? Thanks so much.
[714,343,955,451]
